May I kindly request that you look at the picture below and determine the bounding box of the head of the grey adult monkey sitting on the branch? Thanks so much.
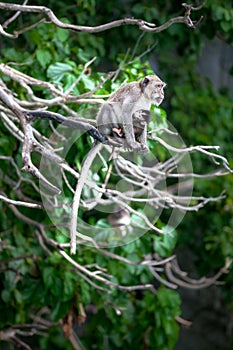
[139,75,166,106]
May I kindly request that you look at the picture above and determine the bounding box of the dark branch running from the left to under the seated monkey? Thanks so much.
[23,111,118,146]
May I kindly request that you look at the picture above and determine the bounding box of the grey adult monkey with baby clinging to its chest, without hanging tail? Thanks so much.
[97,75,166,153]
